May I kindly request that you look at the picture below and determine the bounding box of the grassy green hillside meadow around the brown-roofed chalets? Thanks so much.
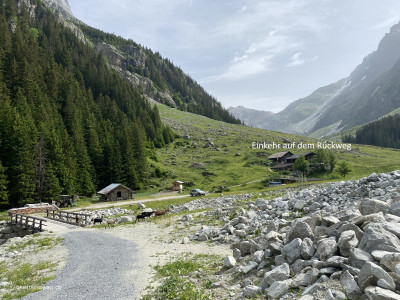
[151,105,400,191]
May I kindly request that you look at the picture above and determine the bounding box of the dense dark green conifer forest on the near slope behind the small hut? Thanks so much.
[0,0,174,206]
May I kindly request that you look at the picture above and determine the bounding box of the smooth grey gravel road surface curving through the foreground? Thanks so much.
[23,229,139,300]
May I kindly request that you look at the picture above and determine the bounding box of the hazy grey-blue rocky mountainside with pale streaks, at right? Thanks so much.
[232,23,400,137]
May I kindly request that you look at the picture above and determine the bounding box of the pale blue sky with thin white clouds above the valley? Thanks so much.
[69,0,400,112]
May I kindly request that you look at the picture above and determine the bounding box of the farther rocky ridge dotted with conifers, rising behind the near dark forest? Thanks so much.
[74,21,240,124]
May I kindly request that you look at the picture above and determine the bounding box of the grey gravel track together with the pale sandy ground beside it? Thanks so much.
[32,212,232,300]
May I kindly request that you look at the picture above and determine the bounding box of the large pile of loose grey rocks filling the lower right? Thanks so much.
[191,171,400,300]
